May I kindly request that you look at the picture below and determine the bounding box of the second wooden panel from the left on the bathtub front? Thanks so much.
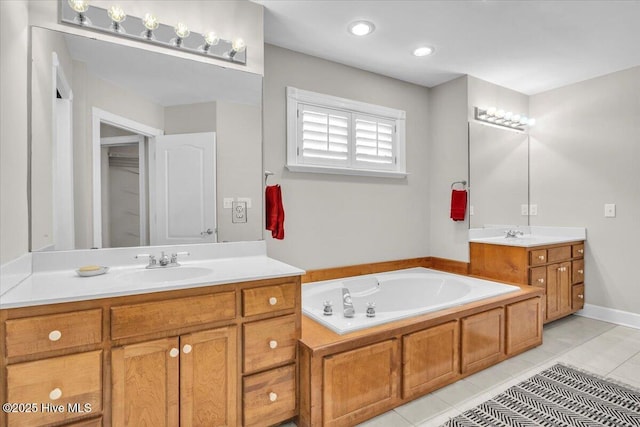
[402,321,460,399]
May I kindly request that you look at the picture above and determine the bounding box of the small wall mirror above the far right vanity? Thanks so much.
[469,122,529,228]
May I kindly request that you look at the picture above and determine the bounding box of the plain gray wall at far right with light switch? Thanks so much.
[531,67,640,314]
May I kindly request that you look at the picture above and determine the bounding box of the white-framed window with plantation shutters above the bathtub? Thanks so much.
[287,87,407,178]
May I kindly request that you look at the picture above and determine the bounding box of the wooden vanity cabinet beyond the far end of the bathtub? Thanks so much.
[469,241,585,323]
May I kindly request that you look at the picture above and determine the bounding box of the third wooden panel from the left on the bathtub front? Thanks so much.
[461,307,504,373]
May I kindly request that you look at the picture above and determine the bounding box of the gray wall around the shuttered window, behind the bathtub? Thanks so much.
[263,45,430,269]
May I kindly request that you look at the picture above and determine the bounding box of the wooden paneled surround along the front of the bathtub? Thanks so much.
[298,286,544,427]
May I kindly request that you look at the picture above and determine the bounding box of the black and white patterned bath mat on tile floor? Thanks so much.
[444,364,640,427]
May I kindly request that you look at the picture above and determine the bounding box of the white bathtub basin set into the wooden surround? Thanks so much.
[302,268,520,334]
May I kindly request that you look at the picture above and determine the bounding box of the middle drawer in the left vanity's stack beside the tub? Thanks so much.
[243,315,299,372]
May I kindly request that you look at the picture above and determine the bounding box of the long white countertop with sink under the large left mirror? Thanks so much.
[0,242,304,309]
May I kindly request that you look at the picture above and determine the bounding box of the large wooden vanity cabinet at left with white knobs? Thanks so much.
[0,276,301,427]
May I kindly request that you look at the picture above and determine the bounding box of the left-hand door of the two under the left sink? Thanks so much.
[111,338,180,427]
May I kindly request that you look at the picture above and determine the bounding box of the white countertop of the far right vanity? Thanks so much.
[469,226,587,248]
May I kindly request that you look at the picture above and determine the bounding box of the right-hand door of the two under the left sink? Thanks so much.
[180,326,238,427]
